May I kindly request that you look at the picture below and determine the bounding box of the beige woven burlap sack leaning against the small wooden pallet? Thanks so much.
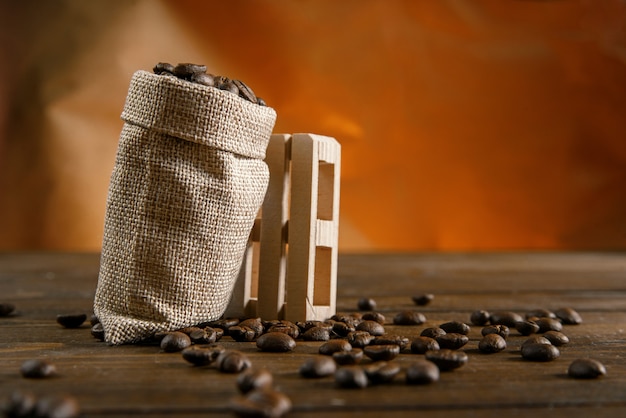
[94,71,276,344]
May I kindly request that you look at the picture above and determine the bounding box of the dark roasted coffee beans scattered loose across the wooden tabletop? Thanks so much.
[3,295,606,418]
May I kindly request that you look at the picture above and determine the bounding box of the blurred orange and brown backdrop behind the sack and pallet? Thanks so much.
[0,0,626,252]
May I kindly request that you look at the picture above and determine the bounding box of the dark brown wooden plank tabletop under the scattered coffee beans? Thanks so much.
[0,253,626,418]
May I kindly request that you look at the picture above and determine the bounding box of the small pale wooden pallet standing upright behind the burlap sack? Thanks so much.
[225,134,341,321]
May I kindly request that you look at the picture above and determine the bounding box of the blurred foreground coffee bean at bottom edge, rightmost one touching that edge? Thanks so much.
[230,388,292,418]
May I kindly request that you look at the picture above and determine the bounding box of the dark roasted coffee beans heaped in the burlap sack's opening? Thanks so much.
[152,62,266,106]
